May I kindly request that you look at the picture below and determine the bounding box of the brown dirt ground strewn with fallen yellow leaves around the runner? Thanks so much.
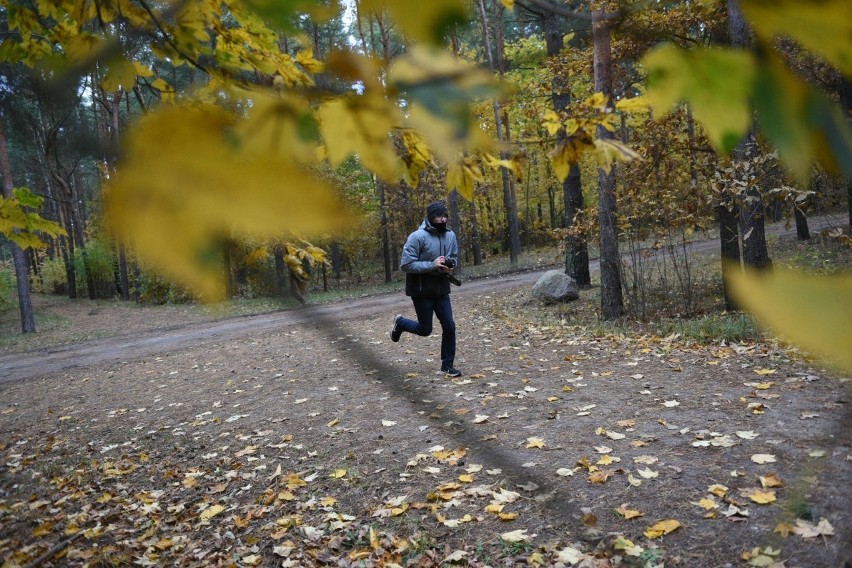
[0,224,852,568]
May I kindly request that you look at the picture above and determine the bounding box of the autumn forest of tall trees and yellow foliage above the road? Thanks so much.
[0,0,852,331]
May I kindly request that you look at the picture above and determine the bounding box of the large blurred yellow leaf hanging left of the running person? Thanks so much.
[105,105,349,300]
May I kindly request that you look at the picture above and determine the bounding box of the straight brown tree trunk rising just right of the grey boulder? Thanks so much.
[592,11,624,321]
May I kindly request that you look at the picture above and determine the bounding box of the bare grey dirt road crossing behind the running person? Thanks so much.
[0,217,835,384]
